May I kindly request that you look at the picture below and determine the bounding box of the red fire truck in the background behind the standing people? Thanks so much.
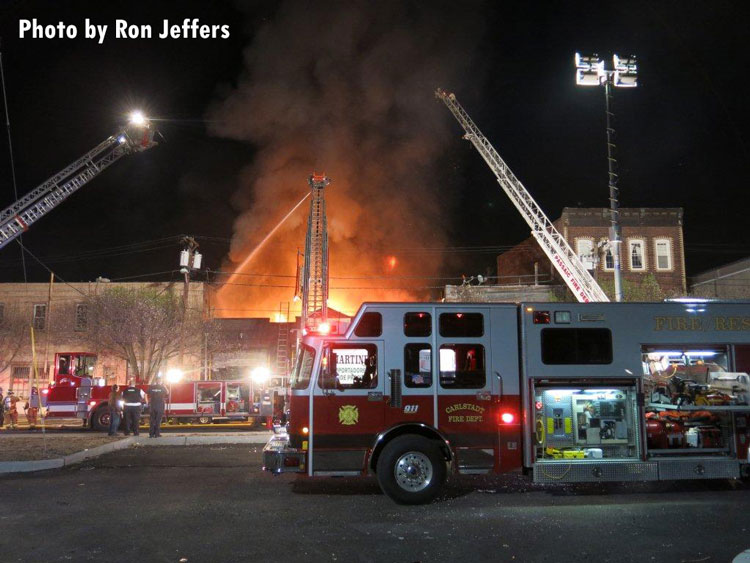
[42,352,273,430]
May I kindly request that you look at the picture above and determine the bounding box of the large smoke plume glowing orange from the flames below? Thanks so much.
[208,1,488,316]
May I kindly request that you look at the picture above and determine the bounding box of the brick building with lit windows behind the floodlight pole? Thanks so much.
[497,207,687,295]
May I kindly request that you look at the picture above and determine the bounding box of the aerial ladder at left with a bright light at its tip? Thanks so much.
[0,112,156,249]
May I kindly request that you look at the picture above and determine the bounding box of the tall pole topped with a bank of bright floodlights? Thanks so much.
[575,53,638,301]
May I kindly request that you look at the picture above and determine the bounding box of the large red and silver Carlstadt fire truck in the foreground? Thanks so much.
[263,300,750,504]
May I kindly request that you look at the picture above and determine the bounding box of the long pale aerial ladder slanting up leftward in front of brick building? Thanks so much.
[435,88,609,303]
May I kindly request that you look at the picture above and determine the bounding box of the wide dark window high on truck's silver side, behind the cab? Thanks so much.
[542,328,612,365]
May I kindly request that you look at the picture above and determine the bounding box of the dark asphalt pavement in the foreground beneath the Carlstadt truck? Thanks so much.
[0,444,750,563]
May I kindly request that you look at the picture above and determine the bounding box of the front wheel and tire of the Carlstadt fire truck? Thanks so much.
[375,434,447,504]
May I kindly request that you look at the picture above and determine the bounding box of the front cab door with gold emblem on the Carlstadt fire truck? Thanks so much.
[309,340,388,474]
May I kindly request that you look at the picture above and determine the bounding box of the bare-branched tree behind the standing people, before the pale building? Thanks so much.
[87,287,207,383]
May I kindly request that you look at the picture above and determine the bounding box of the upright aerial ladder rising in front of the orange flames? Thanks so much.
[301,173,331,332]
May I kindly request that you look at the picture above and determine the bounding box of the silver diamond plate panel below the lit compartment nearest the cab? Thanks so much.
[534,461,659,483]
